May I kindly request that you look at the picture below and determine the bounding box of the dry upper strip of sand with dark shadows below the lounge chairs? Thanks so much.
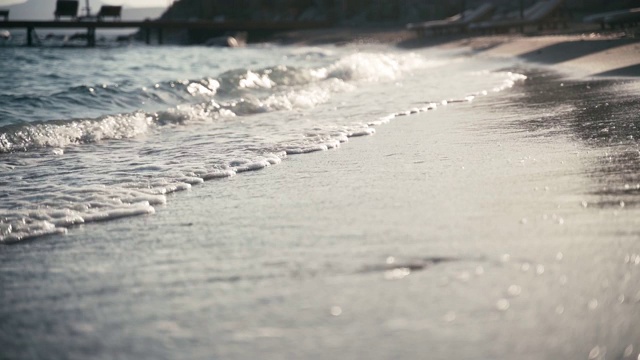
[272,25,640,78]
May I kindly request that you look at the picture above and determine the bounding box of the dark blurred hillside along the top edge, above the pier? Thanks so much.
[156,0,638,23]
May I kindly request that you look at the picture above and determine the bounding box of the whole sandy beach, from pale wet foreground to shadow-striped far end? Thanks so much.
[0,21,640,360]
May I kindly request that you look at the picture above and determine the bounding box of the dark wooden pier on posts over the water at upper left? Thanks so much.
[0,20,329,47]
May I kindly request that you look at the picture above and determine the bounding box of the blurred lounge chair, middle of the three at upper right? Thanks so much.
[469,0,567,33]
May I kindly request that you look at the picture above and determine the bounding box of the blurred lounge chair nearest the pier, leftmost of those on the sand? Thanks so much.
[407,3,495,36]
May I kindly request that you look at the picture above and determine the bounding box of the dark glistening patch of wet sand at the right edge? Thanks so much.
[506,70,640,208]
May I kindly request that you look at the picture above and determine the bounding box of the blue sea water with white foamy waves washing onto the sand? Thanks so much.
[0,45,525,243]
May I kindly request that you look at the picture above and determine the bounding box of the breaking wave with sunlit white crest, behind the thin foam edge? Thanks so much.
[0,53,425,153]
